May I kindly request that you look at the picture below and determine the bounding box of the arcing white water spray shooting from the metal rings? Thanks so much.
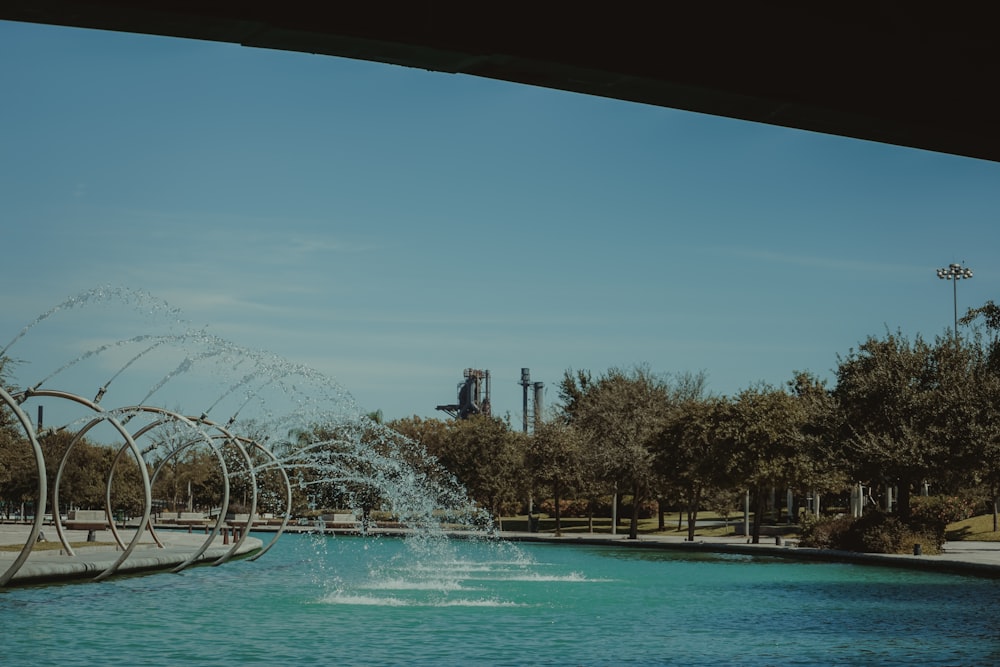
[0,289,508,588]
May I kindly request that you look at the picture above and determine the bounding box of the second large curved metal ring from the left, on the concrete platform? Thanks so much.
[25,389,153,581]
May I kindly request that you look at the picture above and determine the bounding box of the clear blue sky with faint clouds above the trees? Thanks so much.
[0,21,1000,424]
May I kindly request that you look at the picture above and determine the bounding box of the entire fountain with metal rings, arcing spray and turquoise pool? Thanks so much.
[0,290,1000,667]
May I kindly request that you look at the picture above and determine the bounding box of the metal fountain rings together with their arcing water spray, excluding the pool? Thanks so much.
[0,288,488,587]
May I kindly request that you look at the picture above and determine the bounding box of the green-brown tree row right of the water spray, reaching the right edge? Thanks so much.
[390,302,1000,542]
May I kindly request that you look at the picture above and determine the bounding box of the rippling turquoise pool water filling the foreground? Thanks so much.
[0,535,1000,666]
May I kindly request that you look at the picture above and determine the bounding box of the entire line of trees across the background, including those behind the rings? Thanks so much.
[0,302,1000,542]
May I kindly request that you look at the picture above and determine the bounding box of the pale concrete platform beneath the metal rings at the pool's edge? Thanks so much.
[0,524,263,586]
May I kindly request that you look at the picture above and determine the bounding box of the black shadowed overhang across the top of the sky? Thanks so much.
[0,0,1000,161]
